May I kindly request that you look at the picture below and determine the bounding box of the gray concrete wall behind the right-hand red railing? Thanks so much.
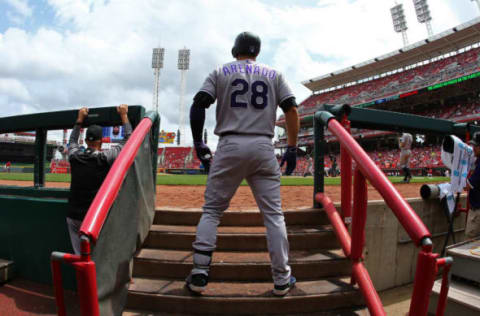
[362,196,466,291]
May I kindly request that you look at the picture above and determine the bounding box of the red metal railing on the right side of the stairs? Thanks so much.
[315,116,452,316]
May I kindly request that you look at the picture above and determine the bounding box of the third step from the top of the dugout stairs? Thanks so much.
[133,248,351,281]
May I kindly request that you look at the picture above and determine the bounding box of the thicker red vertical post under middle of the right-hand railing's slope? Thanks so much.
[350,168,368,261]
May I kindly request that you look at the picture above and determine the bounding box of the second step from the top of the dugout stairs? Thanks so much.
[143,225,339,251]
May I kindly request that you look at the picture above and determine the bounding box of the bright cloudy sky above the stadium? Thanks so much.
[0,0,479,144]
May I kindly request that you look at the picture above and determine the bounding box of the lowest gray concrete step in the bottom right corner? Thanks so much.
[428,279,480,316]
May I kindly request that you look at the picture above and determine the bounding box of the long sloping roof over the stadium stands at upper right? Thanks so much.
[302,17,480,91]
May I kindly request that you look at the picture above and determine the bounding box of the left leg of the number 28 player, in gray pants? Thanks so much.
[187,137,245,292]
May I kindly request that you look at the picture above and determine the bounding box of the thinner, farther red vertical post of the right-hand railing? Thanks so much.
[340,114,352,227]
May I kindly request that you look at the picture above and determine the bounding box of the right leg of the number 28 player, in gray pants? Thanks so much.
[246,139,291,295]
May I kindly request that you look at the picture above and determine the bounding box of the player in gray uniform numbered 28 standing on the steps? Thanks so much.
[186,32,299,296]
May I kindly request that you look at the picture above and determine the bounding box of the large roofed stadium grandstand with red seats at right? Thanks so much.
[275,18,480,174]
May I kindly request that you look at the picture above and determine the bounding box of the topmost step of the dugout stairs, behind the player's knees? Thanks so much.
[153,208,328,226]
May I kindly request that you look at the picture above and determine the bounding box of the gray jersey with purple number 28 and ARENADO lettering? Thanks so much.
[200,60,293,137]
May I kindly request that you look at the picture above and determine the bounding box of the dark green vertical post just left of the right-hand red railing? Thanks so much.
[313,116,325,208]
